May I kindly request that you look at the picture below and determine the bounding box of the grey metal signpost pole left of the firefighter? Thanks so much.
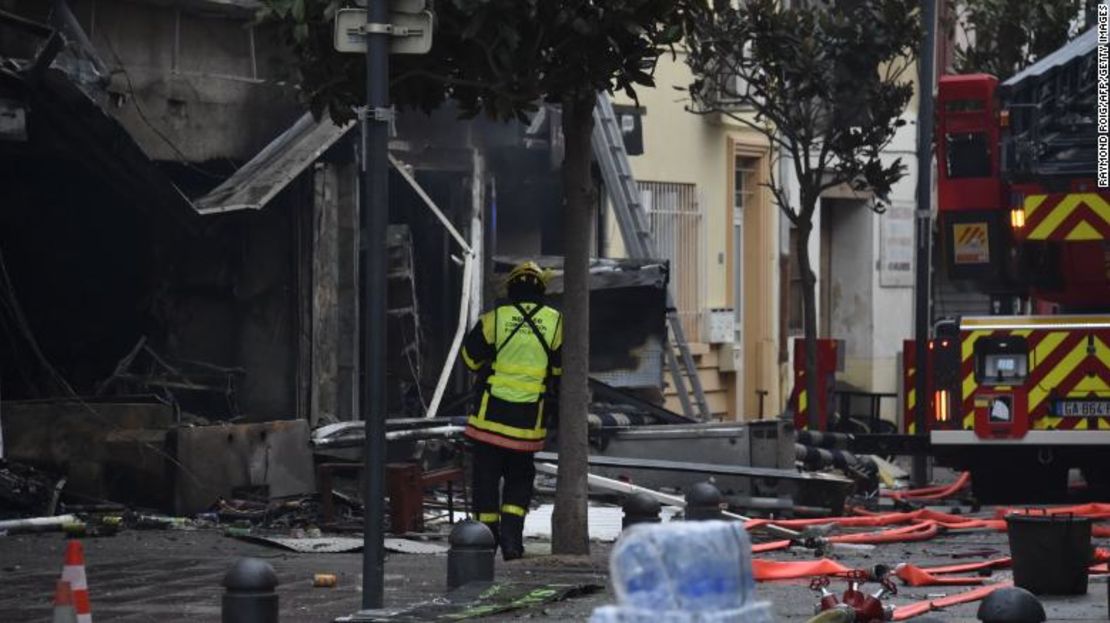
[360,0,390,610]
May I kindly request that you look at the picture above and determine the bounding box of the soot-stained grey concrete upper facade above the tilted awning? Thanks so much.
[73,0,302,162]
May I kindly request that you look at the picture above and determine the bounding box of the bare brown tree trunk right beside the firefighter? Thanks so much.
[552,93,595,555]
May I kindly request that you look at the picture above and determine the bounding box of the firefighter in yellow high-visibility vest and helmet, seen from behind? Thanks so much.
[463,261,563,561]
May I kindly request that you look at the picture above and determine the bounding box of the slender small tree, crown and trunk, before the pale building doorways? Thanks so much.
[686,0,922,423]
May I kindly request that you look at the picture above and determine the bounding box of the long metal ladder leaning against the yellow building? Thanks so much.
[591,92,710,420]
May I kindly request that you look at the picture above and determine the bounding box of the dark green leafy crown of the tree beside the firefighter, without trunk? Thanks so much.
[259,0,687,120]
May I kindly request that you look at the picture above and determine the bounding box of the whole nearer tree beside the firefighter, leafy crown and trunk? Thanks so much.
[260,0,693,554]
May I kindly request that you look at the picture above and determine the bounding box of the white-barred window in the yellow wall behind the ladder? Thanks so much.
[639,182,705,342]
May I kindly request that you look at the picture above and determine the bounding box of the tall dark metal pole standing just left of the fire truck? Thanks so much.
[912,0,937,486]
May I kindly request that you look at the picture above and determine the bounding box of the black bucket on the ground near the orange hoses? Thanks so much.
[1006,510,1091,595]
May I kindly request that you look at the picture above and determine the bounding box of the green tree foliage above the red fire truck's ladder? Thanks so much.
[945,0,1098,80]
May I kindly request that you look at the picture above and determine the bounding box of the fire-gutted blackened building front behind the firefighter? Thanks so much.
[0,0,666,515]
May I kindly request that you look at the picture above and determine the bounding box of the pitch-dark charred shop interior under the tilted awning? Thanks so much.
[0,153,311,420]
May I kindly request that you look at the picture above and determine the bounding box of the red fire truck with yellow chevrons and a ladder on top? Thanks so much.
[902,29,1110,502]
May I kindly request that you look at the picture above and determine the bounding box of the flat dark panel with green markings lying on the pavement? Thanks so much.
[335,582,604,623]
